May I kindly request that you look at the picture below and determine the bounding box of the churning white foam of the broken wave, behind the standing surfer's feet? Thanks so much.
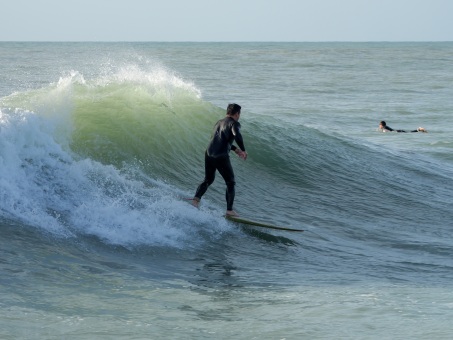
[0,109,228,247]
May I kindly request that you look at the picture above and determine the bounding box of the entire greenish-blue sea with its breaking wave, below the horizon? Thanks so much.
[0,42,453,339]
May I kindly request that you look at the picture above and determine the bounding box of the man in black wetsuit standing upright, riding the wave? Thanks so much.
[191,104,247,216]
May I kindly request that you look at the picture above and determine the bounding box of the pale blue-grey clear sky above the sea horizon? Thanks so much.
[0,0,453,42]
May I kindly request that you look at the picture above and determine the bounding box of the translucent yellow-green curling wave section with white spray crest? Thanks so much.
[0,67,222,185]
